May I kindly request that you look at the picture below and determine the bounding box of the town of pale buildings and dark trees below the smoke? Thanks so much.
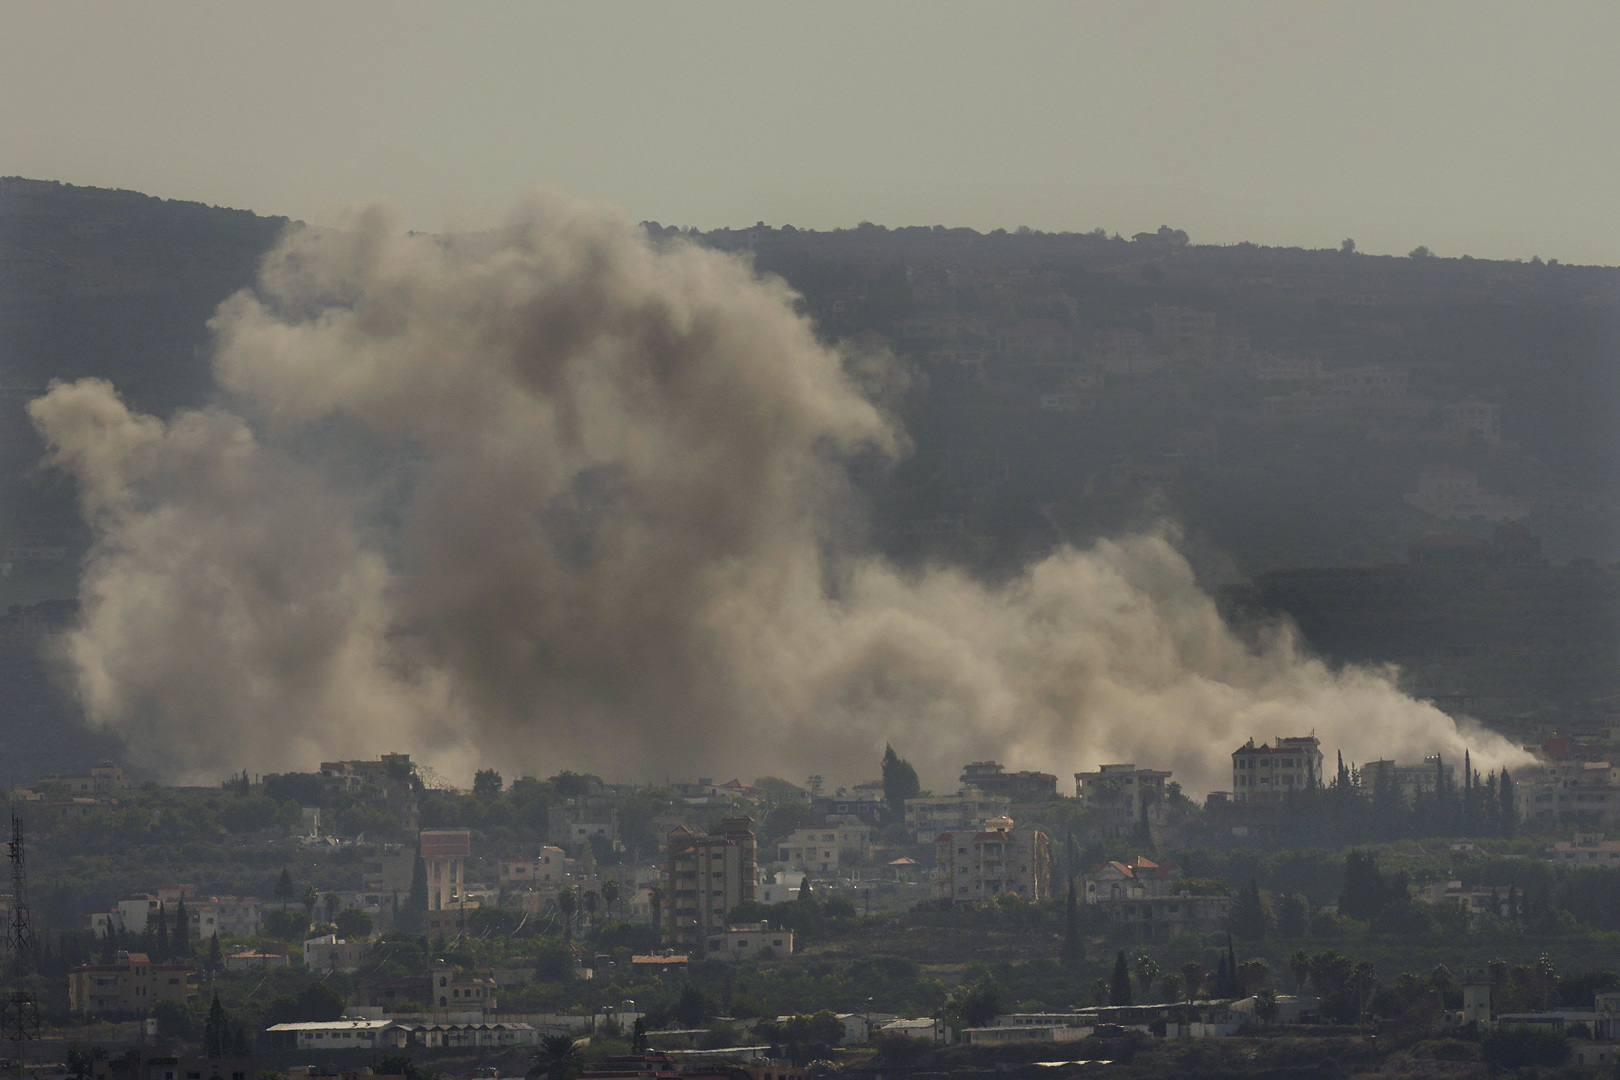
[3,732,1620,1080]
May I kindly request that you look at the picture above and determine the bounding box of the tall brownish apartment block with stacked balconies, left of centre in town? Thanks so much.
[664,818,757,949]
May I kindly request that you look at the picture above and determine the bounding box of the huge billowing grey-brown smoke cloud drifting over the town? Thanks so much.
[31,194,1515,790]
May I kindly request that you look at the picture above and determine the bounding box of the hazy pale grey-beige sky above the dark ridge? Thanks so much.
[0,0,1620,264]
